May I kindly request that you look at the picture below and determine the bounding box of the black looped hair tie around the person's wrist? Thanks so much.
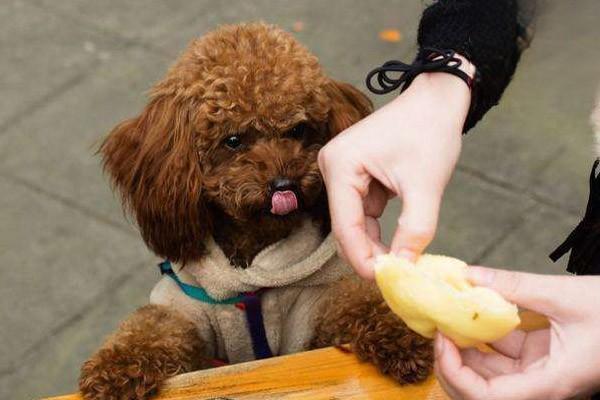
[366,47,473,94]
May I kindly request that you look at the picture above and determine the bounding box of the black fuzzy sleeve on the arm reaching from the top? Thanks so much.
[417,0,524,132]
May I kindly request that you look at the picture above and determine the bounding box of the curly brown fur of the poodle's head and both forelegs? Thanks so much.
[80,23,432,399]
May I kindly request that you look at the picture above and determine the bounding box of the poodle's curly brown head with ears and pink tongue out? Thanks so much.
[101,23,372,263]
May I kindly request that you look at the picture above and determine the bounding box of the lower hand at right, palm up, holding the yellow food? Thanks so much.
[435,267,600,400]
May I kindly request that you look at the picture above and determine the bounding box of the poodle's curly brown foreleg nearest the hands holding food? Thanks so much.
[312,279,433,384]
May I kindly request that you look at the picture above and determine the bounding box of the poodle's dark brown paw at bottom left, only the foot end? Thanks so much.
[79,346,180,400]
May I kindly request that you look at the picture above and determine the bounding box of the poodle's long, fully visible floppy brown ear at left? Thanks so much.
[100,96,211,263]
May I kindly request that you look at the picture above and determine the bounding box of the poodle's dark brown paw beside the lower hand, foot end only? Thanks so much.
[352,303,434,384]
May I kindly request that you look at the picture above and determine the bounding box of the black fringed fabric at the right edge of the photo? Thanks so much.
[550,160,600,275]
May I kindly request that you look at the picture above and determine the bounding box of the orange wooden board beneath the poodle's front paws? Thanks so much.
[47,347,447,400]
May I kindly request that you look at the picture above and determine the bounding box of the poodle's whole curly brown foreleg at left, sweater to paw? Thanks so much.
[79,305,206,400]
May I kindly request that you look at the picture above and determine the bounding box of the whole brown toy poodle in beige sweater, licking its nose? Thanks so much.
[80,23,433,399]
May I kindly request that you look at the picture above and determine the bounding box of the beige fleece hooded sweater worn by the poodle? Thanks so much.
[150,220,351,363]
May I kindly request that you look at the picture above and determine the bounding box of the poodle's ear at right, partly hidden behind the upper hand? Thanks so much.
[325,80,373,137]
